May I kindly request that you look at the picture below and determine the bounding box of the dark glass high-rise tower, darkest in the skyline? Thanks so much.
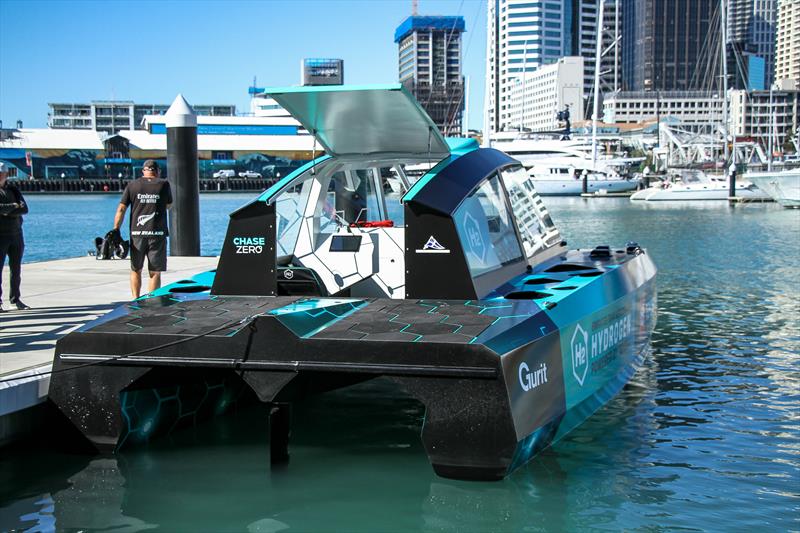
[622,0,721,91]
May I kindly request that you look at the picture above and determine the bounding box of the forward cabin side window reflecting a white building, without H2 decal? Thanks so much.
[501,167,561,257]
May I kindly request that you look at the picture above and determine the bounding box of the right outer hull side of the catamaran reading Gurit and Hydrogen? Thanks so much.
[503,255,656,471]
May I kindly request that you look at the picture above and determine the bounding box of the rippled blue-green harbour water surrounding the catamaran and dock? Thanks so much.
[0,195,800,532]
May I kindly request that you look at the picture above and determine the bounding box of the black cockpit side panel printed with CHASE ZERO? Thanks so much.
[211,202,277,296]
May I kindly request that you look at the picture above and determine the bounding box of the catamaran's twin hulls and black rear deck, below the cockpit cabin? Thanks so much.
[50,252,655,479]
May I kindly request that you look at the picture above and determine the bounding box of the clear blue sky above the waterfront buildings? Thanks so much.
[0,0,486,128]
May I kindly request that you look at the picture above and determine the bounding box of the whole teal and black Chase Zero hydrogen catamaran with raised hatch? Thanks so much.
[50,85,656,479]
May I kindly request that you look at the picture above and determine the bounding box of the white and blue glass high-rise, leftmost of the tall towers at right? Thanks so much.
[486,0,572,132]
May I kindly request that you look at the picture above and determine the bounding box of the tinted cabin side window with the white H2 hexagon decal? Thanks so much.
[454,175,523,277]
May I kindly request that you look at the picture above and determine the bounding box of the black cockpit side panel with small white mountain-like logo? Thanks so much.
[405,202,477,300]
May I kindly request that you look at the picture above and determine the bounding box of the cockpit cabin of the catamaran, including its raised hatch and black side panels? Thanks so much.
[212,85,560,298]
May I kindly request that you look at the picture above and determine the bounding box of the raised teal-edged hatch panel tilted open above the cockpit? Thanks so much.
[265,84,450,160]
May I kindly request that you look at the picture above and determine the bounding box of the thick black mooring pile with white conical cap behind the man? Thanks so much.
[166,94,200,256]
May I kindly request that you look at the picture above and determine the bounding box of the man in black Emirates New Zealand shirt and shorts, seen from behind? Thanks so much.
[114,159,172,300]
